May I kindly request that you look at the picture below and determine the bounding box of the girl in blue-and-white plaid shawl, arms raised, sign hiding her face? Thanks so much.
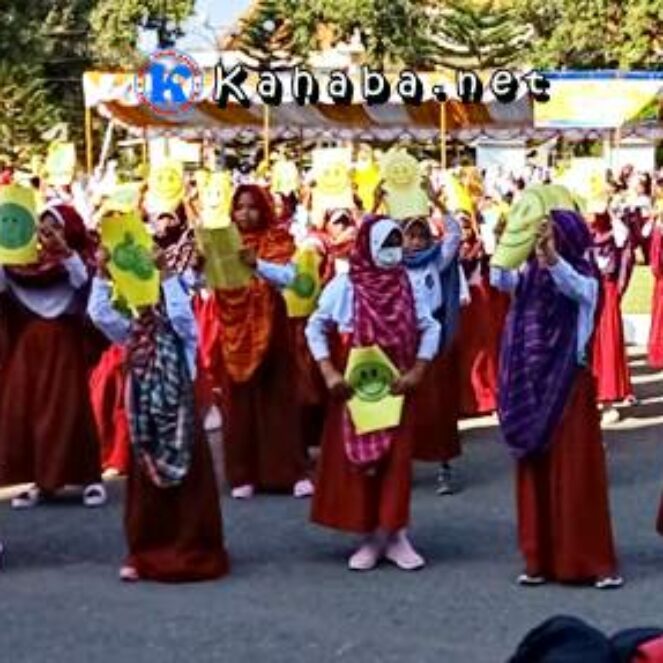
[88,246,228,582]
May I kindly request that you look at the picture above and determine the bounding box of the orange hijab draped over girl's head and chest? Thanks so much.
[216,184,295,382]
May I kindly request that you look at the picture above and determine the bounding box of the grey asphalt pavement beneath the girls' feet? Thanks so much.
[0,355,663,663]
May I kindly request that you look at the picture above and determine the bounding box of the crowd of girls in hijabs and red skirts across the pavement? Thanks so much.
[0,157,663,589]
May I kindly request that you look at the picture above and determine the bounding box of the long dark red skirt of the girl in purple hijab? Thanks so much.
[516,369,617,582]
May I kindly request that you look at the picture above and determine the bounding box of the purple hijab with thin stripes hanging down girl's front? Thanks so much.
[498,211,596,459]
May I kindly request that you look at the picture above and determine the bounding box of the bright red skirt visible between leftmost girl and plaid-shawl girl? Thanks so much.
[90,345,131,474]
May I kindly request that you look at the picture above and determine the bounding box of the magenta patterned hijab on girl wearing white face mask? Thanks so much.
[344,215,418,466]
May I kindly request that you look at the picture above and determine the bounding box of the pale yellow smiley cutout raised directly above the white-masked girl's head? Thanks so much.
[380,149,428,219]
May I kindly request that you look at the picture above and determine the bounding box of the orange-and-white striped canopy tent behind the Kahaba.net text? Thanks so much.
[83,64,533,141]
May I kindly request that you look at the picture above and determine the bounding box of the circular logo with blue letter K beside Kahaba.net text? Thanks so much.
[135,49,203,118]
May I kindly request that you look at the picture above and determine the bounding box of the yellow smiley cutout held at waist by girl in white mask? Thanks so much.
[345,345,404,435]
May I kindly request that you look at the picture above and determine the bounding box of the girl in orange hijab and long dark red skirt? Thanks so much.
[215,184,313,499]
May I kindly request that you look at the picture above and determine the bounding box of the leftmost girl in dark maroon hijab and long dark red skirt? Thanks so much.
[0,204,106,509]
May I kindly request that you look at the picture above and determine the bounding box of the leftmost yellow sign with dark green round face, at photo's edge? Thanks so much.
[0,184,39,265]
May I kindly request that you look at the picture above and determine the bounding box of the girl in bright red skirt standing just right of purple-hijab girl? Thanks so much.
[587,210,635,423]
